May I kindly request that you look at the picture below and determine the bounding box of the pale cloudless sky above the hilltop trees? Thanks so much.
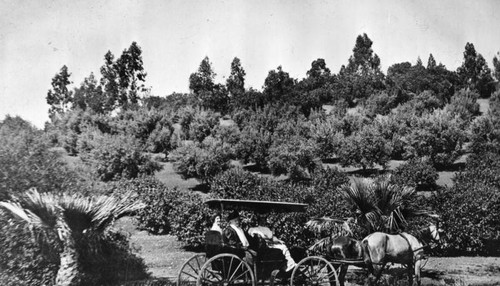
[0,0,500,127]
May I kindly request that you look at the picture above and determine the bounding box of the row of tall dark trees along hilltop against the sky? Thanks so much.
[46,34,500,120]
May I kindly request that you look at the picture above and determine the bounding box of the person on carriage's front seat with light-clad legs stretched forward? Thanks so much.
[248,214,297,272]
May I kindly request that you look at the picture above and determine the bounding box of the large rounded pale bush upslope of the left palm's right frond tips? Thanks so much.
[81,134,161,181]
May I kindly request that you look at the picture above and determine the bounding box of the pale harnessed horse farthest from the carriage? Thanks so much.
[361,224,441,286]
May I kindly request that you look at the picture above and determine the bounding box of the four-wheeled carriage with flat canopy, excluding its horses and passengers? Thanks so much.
[177,200,339,286]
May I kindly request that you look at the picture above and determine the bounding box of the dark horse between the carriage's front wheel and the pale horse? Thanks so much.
[308,236,363,286]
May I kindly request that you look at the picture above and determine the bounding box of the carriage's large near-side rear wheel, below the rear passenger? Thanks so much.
[196,253,255,286]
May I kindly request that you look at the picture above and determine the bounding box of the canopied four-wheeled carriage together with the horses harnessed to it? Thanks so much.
[177,199,439,286]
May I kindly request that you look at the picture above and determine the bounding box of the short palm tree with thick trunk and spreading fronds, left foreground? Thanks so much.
[0,189,143,286]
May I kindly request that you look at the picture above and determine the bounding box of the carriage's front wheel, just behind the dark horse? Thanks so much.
[290,256,340,286]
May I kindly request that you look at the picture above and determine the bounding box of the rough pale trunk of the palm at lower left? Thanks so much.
[55,235,79,286]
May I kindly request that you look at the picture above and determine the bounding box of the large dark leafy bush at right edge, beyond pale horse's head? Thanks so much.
[431,153,500,255]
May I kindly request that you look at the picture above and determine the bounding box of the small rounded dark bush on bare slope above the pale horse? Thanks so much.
[391,158,439,191]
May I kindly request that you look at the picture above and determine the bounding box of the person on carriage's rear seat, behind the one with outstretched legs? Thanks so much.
[222,211,257,265]
